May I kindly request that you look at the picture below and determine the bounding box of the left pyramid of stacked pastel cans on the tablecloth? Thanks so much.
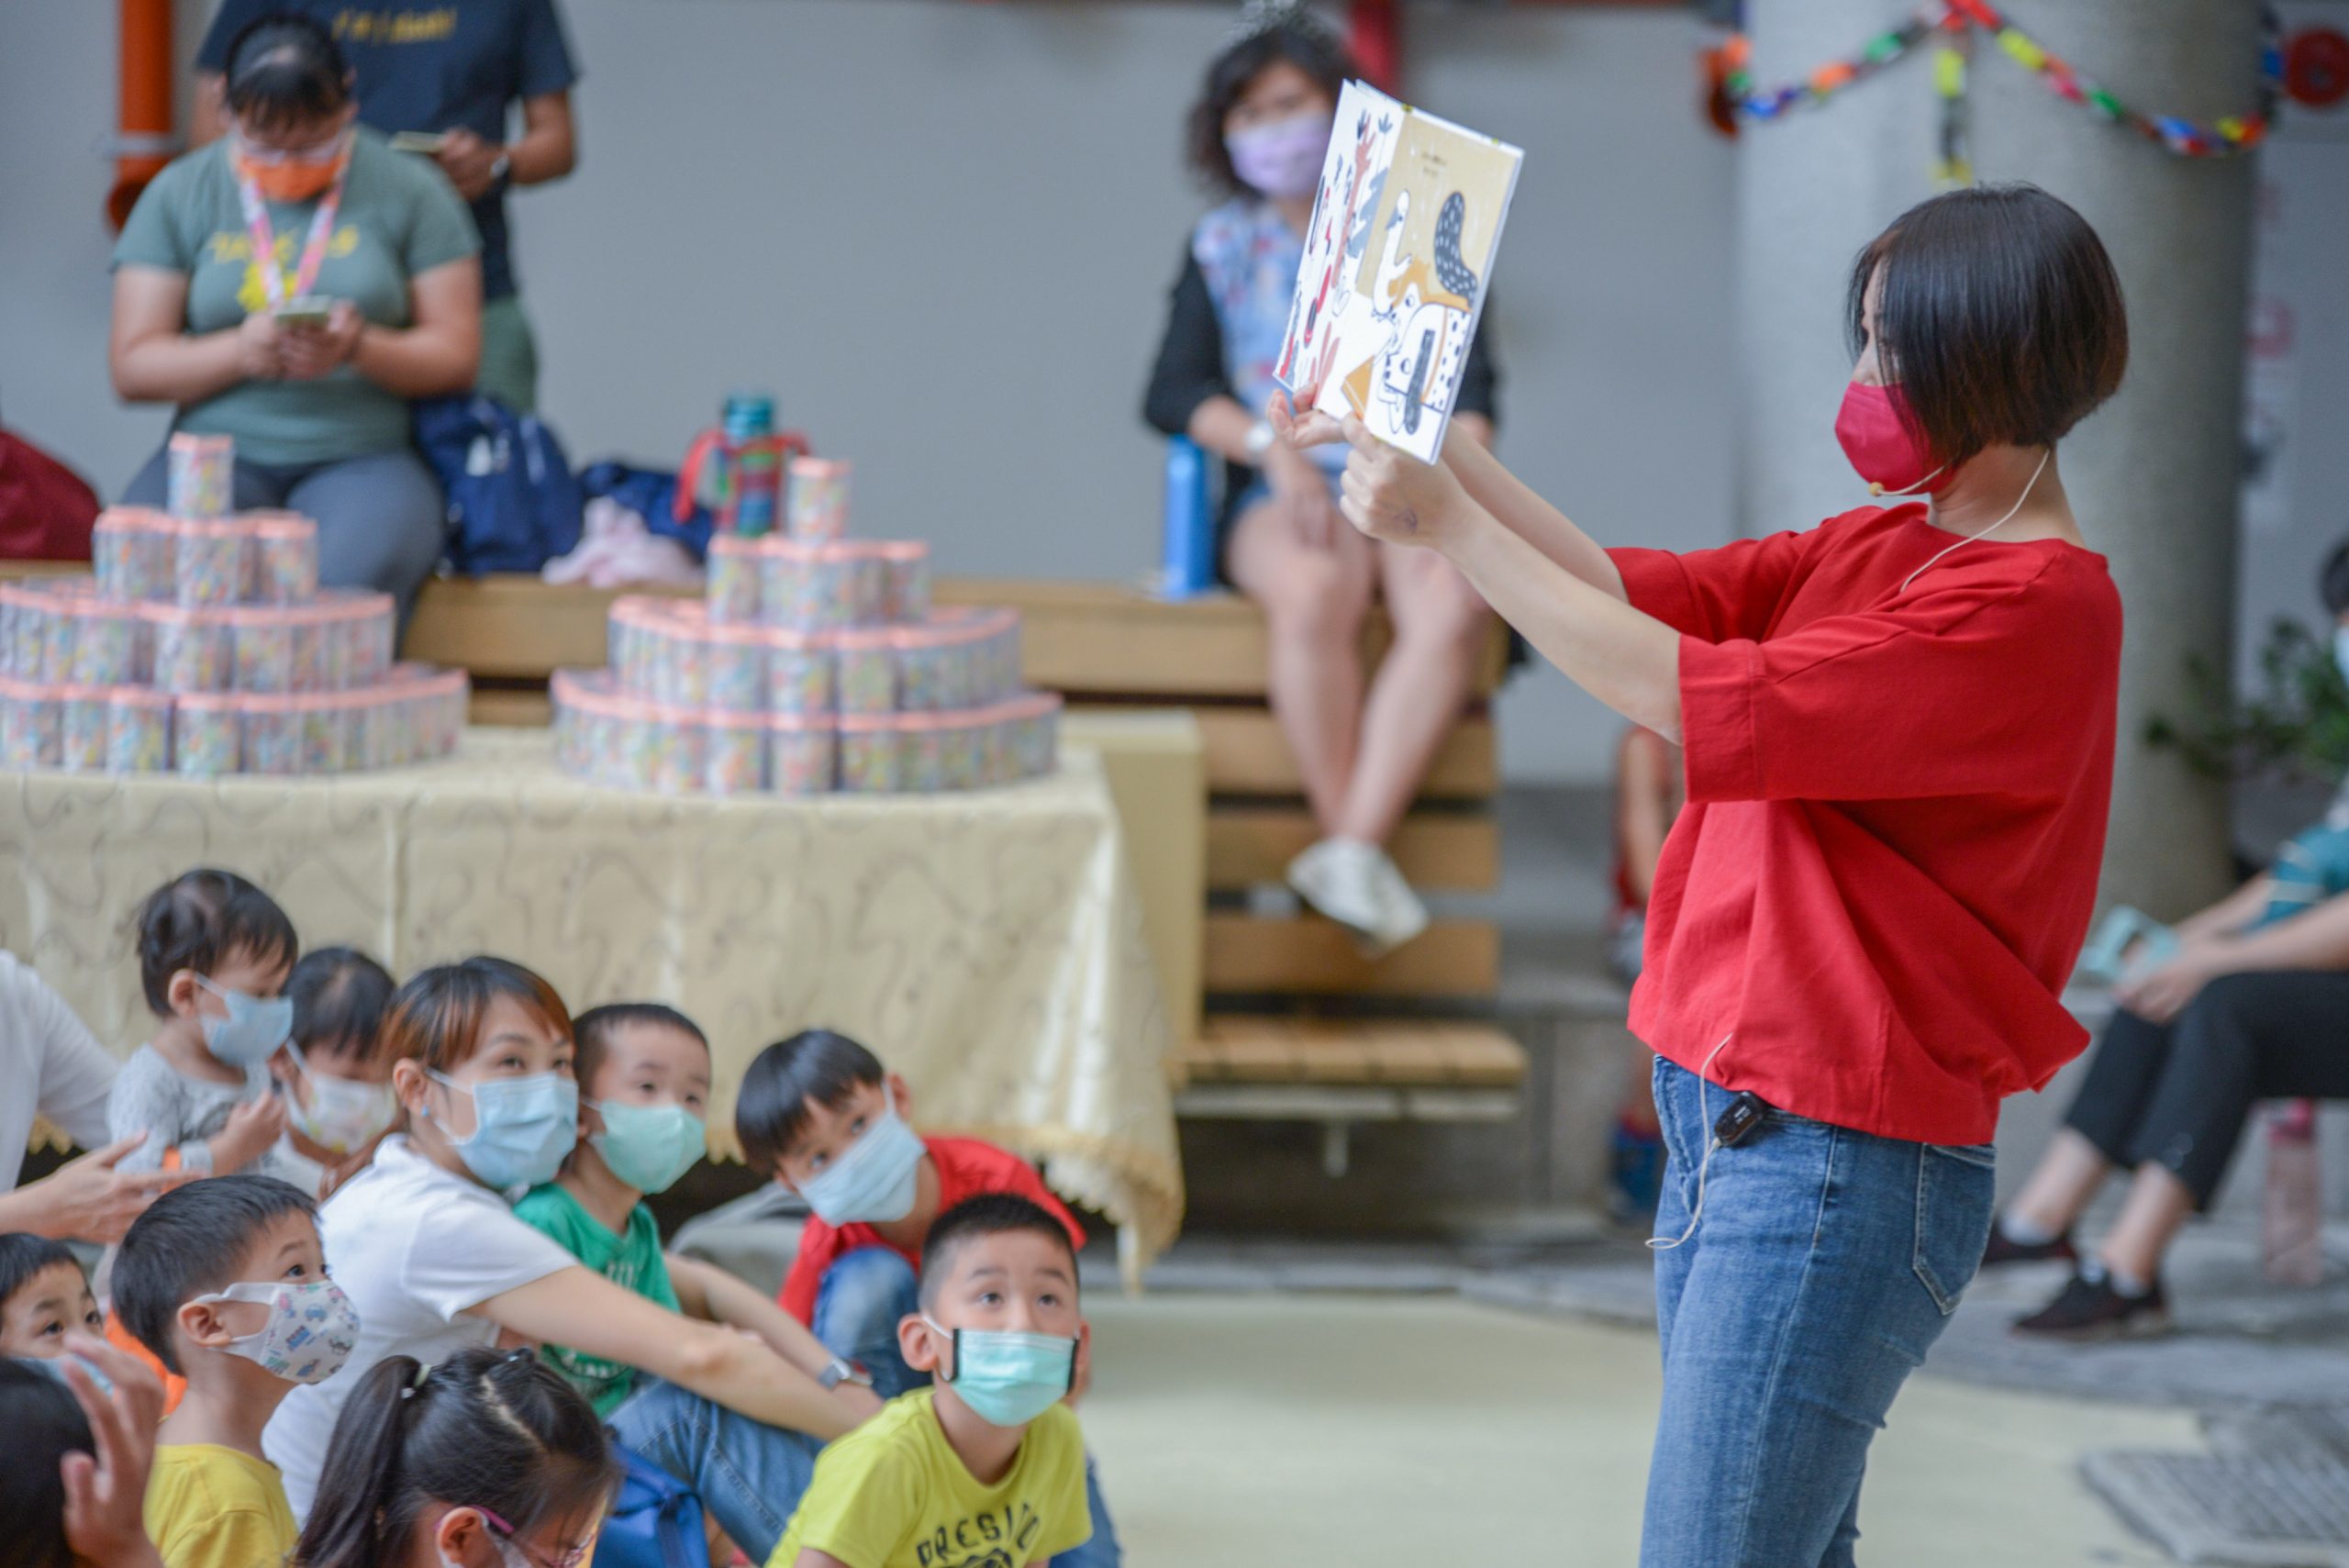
[0,434,467,777]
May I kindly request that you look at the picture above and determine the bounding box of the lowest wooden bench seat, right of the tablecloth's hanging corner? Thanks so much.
[1182,1014,1524,1089]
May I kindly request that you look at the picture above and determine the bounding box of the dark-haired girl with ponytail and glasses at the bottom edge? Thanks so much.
[294,1345,618,1568]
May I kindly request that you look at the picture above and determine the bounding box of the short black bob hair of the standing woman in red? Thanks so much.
[1846,185,2128,478]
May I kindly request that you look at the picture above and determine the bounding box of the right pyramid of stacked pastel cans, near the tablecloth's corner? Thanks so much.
[552,460,1060,795]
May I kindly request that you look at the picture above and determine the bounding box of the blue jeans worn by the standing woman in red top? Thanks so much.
[1640,1059,1994,1568]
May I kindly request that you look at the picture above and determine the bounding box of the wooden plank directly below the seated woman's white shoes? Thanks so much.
[1205,913,1501,997]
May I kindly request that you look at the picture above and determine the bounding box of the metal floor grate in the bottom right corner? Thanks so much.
[2081,1453,2349,1568]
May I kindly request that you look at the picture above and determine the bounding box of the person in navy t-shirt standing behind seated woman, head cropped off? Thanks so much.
[195,0,578,413]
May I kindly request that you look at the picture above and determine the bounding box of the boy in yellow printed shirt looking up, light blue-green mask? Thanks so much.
[768,1193,1092,1568]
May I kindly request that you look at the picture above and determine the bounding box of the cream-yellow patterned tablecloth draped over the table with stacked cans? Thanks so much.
[0,730,1182,1270]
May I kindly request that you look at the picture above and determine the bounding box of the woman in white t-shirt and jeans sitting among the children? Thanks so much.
[263,958,874,1561]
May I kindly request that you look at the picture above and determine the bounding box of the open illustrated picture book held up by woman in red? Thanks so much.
[1275,83,1524,462]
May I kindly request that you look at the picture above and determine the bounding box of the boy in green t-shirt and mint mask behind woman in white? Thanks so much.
[515,1002,881,1420]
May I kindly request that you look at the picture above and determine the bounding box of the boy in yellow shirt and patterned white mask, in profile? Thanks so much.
[113,1173,360,1568]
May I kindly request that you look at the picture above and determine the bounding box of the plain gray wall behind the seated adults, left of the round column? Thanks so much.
[0,0,1731,779]
